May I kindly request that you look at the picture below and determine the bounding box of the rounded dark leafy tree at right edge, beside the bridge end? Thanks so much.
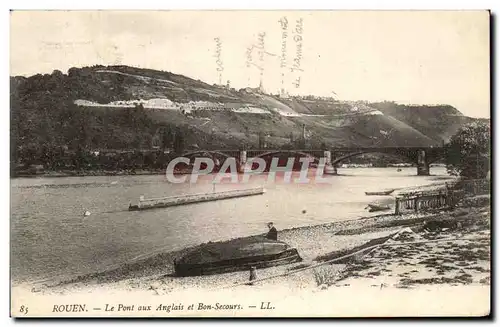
[446,122,491,178]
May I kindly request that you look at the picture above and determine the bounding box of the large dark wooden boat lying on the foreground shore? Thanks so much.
[174,236,302,277]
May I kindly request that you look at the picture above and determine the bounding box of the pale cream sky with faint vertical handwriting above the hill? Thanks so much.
[10,11,490,118]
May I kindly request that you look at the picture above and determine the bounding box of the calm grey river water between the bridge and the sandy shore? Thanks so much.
[11,167,454,283]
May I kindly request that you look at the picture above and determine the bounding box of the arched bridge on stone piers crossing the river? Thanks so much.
[182,147,445,176]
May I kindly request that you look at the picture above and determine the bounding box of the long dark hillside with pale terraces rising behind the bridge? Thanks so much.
[10,66,482,170]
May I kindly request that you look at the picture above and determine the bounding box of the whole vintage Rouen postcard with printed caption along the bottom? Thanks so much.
[10,10,491,318]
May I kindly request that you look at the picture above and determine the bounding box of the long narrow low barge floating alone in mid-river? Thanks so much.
[128,187,265,211]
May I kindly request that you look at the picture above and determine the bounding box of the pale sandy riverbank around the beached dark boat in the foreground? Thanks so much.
[16,193,490,295]
